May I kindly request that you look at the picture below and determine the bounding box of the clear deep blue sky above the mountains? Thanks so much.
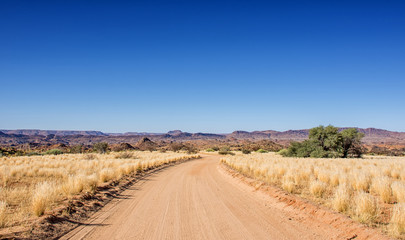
[0,0,405,133]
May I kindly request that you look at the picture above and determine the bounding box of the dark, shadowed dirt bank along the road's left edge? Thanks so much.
[0,154,202,239]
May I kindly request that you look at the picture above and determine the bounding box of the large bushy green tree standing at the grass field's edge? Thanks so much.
[281,125,364,158]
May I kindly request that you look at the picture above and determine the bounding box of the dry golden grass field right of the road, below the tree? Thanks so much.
[221,153,405,239]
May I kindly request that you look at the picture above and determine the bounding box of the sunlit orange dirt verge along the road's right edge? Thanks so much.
[218,163,393,240]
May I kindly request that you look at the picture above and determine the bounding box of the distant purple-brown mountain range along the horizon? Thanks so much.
[0,128,405,146]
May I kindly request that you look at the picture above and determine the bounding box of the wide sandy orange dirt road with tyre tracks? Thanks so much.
[62,156,376,240]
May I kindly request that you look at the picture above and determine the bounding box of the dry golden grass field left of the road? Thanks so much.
[0,152,198,227]
